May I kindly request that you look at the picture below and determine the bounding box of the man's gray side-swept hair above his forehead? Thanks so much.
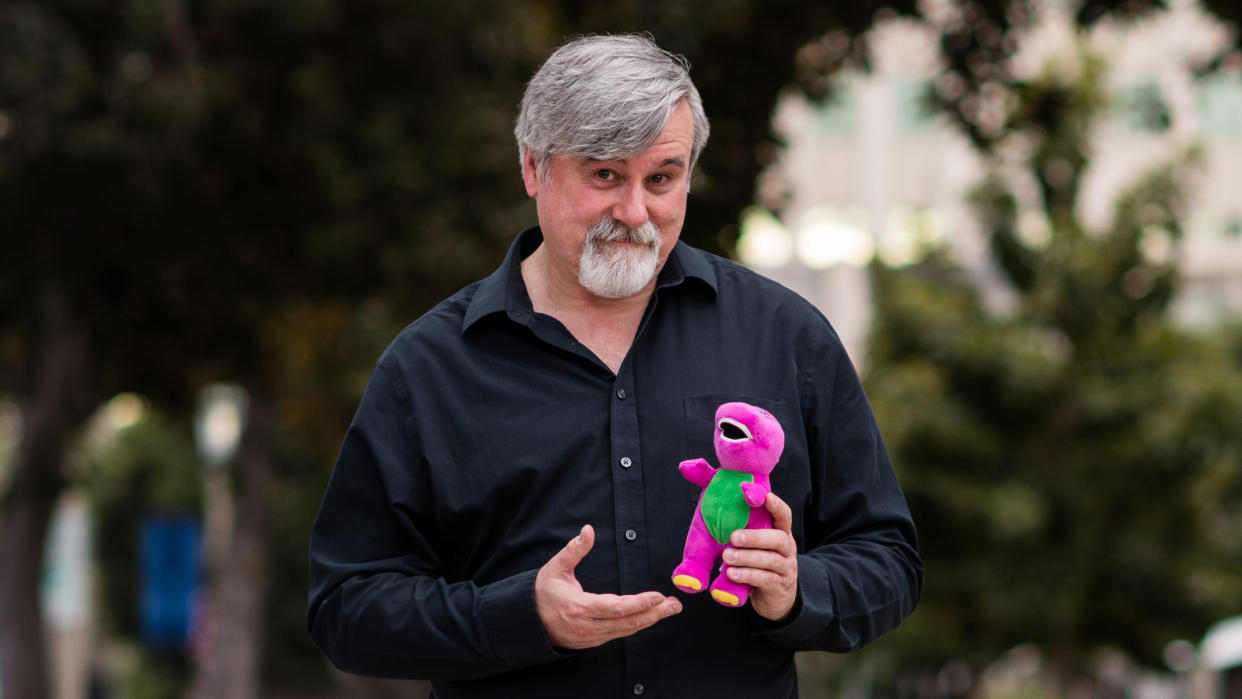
[513,34,709,179]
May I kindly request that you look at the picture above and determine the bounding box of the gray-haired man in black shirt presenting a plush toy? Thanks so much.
[308,36,923,699]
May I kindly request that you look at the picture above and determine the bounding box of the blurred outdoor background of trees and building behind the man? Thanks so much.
[0,0,1242,699]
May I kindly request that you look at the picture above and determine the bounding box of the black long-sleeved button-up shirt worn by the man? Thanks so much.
[308,228,923,699]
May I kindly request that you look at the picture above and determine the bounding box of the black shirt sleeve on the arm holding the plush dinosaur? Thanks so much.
[760,328,923,652]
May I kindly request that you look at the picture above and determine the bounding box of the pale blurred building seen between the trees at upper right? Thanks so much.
[738,0,1242,361]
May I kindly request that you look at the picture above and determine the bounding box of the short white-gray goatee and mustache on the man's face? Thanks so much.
[578,217,660,298]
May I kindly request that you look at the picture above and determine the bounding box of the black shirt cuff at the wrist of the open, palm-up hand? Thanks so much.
[479,570,564,668]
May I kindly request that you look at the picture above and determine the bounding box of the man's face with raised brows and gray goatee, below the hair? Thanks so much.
[522,103,694,298]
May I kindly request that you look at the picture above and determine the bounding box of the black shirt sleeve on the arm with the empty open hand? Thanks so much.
[307,359,563,680]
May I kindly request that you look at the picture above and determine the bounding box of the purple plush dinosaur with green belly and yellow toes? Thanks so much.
[673,402,785,607]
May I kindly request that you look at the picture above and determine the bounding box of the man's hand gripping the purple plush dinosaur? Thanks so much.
[724,493,797,621]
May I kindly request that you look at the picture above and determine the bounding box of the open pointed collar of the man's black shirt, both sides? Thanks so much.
[462,226,717,333]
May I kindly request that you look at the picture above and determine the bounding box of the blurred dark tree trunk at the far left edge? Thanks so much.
[0,303,93,699]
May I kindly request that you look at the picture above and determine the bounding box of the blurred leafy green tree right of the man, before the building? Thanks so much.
[867,34,1242,687]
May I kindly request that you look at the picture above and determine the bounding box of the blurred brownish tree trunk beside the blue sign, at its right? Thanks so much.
[193,395,276,699]
